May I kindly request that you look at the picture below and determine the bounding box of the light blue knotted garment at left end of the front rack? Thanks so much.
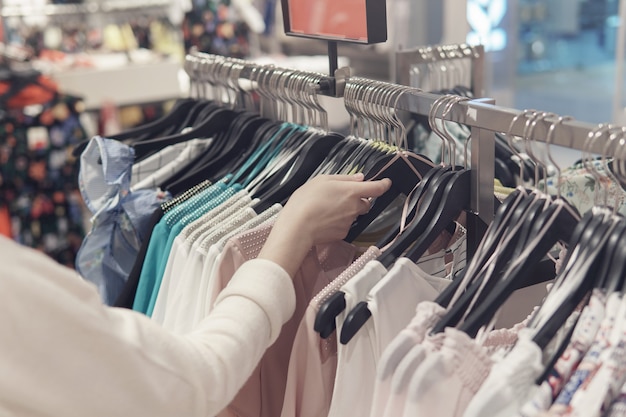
[76,136,171,305]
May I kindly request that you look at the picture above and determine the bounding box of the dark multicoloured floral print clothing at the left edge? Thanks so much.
[0,96,86,267]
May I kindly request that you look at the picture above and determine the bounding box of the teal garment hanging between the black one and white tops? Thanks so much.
[133,178,241,316]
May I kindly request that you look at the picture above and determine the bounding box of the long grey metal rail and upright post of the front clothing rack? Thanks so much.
[186,53,620,256]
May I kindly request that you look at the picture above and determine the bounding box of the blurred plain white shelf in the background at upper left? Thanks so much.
[51,61,184,110]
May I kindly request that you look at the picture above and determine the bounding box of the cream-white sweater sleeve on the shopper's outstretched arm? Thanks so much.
[0,238,295,417]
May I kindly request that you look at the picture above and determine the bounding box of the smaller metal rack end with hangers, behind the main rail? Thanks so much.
[394,44,485,97]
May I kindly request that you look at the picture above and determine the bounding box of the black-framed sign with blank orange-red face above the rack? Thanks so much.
[281,0,387,44]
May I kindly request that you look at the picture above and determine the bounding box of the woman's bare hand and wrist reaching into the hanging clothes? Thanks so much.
[259,174,391,277]
